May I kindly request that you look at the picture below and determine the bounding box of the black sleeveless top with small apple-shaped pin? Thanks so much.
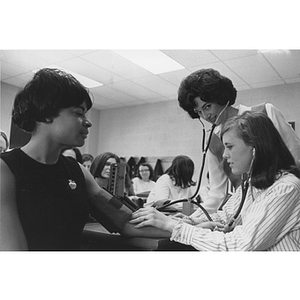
[1,148,89,250]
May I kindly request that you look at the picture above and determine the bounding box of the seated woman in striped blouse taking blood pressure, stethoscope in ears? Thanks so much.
[130,112,300,251]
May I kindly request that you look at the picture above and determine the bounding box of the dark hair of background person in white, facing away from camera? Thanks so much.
[165,155,196,189]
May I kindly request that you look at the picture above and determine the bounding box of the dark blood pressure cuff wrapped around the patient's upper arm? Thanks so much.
[89,189,132,232]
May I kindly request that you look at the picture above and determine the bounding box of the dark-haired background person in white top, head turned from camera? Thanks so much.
[147,155,196,209]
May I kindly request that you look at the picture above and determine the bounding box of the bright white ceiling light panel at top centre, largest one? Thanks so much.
[114,50,185,74]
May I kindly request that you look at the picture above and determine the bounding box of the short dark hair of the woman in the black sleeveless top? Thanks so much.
[12,68,92,132]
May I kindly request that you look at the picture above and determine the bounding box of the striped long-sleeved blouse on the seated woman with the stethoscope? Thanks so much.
[171,173,300,251]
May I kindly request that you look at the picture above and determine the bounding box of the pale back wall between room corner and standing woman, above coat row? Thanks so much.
[98,100,202,177]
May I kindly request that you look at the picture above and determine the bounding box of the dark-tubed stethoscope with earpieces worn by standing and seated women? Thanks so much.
[157,101,253,232]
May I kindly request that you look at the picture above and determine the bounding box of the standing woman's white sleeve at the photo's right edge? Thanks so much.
[266,103,300,165]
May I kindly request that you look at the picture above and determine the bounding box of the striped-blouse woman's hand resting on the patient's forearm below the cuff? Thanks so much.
[129,207,177,232]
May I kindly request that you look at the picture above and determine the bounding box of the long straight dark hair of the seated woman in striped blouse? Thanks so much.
[221,112,300,189]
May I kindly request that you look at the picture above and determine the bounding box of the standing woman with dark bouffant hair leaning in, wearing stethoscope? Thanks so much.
[178,69,300,212]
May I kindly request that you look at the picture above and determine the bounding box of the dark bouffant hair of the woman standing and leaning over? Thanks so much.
[178,69,237,119]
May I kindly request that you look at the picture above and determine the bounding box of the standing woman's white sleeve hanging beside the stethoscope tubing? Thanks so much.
[203,150,228,211]
